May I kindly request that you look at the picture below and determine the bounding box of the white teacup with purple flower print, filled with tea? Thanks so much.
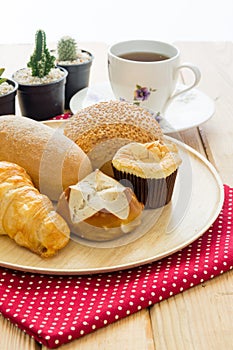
[108,40,201,113]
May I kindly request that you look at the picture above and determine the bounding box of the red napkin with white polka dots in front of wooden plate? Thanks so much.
[0,186,233,348]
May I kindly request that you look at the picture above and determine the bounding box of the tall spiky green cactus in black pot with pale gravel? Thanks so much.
[13,29,67,121]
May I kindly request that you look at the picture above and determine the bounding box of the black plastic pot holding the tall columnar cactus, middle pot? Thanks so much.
[14,68,68,121]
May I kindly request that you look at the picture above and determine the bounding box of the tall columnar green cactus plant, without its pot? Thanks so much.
[28,30,55,78]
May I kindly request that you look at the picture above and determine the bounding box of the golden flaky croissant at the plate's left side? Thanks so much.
[0,161,70,257]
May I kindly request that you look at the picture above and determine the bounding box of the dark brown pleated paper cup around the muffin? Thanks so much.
[112,166,177,209]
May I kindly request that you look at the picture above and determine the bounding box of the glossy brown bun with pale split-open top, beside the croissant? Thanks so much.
[57,170,144,241]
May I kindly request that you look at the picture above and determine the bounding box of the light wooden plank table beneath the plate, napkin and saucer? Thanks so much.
[0,42,233,350]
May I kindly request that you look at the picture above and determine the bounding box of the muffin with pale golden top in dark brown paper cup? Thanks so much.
[112,141,181,209]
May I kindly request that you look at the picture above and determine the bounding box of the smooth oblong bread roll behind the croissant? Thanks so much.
[0,116,92,200]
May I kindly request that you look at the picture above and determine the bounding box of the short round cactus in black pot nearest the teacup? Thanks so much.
[57,36,93,109]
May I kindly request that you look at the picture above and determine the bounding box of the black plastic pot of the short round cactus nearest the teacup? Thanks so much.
[57,50,94,109]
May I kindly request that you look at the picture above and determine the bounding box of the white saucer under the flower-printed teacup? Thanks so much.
[70,82,215,134]
